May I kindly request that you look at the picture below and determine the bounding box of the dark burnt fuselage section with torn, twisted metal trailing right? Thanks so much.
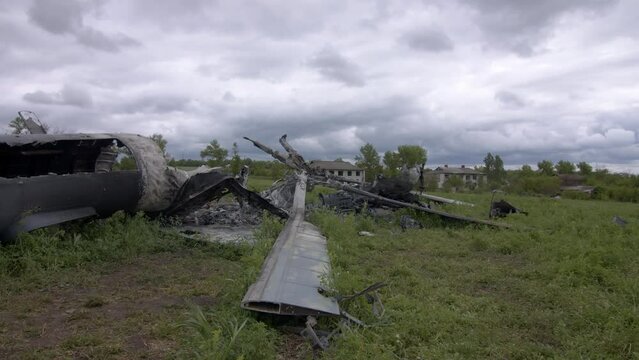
[0,133,288,241]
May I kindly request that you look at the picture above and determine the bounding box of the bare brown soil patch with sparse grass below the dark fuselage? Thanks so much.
[0,254,233,359]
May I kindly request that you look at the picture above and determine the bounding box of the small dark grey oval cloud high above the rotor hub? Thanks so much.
[308,48,366,86]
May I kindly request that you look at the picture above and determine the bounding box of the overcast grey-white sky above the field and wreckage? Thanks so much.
[0,0,639,172]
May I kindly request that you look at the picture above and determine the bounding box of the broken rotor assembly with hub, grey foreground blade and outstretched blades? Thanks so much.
[242,135,507,348]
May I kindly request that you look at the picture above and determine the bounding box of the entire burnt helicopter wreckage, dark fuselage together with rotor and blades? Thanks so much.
[0,121,507,348]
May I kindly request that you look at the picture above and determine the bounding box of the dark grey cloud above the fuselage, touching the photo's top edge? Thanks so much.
[28,0,139,52]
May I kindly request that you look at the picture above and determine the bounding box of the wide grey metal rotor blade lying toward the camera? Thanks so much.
[242,173,340,316]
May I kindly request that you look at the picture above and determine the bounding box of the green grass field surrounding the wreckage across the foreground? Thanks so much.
[0,190,639,359]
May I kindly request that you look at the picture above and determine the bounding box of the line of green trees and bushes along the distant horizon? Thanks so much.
[110,129,639,202]
